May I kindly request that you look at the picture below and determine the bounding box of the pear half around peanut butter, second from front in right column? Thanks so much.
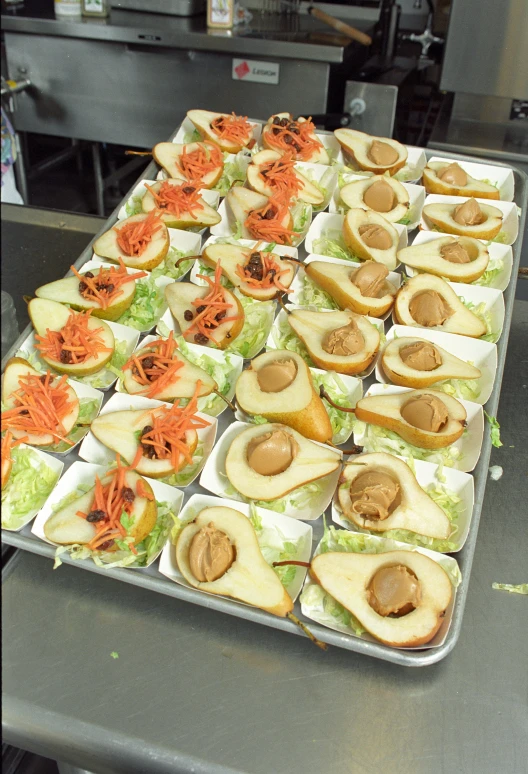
[337,452,451,540]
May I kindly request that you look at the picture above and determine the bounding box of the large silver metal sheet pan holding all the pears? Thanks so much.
[2,135,528,667]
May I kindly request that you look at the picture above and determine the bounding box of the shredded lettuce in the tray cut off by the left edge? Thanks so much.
[2,447,59,529]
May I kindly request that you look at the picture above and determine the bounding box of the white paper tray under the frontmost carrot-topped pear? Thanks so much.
[31,460,183,570]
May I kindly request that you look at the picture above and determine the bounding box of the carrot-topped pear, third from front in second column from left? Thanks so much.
[122,331,217,401]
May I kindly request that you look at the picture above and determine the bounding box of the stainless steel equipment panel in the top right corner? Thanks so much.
[440,0,528,99]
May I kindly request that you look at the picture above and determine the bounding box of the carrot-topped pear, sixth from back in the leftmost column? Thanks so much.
[28,298,115,377]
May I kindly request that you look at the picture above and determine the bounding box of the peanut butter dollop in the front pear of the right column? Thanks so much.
[368,564,422,617]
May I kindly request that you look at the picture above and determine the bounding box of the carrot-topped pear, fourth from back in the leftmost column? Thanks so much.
[93,212,170,271]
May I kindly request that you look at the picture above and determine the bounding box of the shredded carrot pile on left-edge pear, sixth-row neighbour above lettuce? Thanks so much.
[2,371,75,446]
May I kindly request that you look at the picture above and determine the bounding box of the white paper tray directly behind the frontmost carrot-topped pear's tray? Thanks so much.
[79,392,218,489]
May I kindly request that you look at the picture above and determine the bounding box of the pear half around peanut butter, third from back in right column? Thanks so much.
[398,236,489,283]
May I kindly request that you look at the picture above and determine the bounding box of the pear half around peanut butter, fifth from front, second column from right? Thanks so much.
[304,261,396,317]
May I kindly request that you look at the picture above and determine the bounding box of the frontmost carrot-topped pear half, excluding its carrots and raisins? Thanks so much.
[44,470,158,551]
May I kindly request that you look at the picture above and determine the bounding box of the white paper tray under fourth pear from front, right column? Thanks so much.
[376,325,497,405]
